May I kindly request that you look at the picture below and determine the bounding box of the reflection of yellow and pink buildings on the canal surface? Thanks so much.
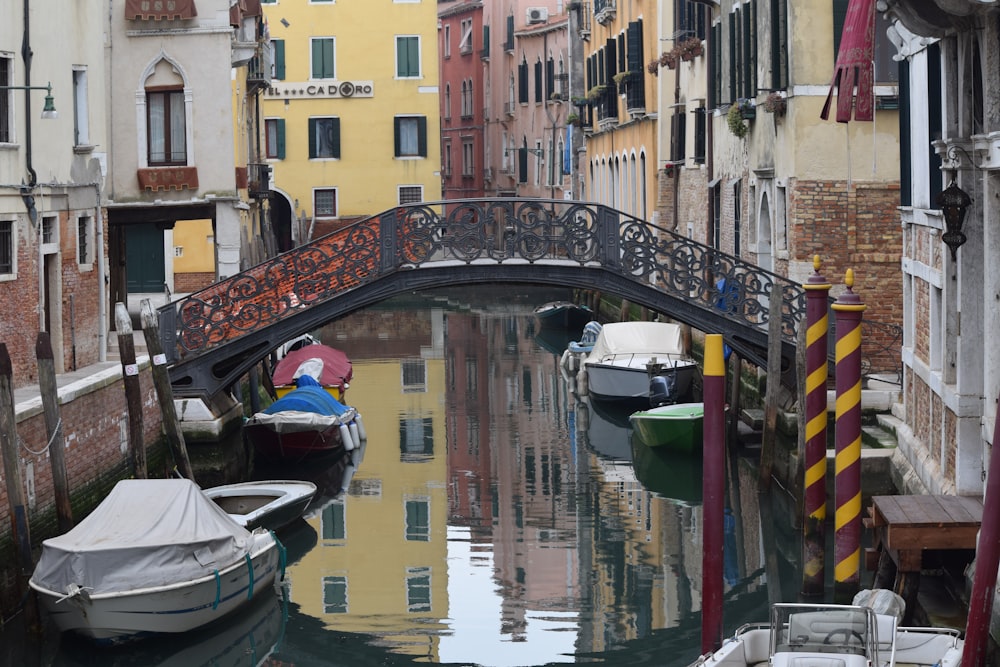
[274,296,766,665]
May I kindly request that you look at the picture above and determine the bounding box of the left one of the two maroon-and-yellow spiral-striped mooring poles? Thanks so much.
[802,255,830,597]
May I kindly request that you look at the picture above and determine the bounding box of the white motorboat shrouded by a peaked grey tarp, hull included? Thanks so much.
[29,479,283,643]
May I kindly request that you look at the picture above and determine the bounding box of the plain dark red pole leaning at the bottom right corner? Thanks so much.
[962,396,1000,667]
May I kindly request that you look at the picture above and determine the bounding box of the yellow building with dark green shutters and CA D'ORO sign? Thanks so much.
[263,0,441,250]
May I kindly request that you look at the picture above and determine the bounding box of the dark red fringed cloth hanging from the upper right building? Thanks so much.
[820,0,875,123]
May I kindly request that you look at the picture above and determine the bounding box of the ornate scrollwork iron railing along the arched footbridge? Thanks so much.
[160,199,904,390]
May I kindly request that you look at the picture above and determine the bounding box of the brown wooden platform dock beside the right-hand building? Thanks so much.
[864,495,983,623]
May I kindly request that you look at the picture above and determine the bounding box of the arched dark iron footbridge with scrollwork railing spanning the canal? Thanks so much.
[158,198,898,400]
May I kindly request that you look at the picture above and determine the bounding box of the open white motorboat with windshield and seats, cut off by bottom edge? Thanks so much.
[691,591,963,667]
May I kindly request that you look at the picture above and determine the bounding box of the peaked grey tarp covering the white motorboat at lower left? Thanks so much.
[31,479,252,595]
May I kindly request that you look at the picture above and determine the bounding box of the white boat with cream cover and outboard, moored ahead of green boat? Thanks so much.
[577,322,698,407]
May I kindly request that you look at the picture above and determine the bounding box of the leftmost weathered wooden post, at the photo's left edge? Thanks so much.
[0,343,33,596]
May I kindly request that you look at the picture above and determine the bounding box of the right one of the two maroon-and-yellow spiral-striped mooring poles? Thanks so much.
[833,269,865,601]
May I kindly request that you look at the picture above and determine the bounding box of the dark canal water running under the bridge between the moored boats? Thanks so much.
[0,286,799,667]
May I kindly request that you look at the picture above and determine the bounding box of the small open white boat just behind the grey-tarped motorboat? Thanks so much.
[203,479,316,530]
